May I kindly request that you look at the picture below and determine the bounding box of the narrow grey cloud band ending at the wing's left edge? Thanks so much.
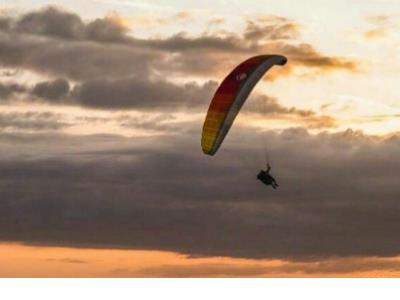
[0,77,217,112]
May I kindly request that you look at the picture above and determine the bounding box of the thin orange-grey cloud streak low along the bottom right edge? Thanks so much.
[135,257,400,277]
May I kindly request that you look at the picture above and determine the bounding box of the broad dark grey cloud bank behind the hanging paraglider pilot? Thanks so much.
[0,128,400,260]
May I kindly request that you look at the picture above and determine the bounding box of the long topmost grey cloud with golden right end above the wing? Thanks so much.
[0,7,356,81]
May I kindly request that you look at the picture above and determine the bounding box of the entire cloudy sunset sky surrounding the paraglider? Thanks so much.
[0,0,400,277]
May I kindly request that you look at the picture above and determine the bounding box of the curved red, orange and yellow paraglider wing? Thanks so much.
[201,55,287,155]
